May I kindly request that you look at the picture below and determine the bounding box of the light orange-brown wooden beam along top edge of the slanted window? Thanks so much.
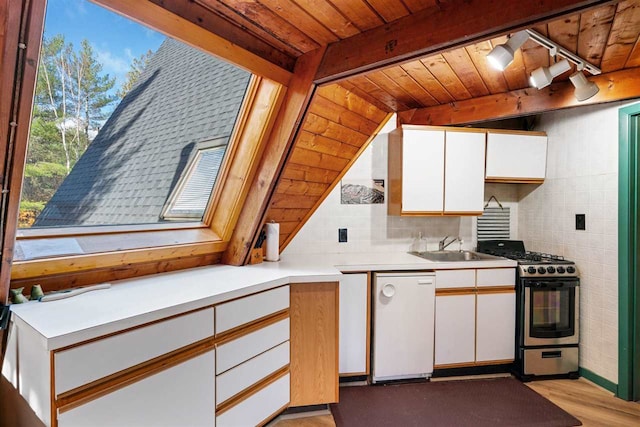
[91,0,291,86]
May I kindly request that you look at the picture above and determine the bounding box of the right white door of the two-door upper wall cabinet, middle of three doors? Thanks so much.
[444,131,485,215]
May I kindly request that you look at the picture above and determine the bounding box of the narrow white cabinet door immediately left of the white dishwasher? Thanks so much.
[339,274,369,375]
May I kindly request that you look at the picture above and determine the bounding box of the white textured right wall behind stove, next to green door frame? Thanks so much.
[518,103,629,383]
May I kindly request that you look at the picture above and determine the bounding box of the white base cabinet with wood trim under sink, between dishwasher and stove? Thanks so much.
[434,268,515,369]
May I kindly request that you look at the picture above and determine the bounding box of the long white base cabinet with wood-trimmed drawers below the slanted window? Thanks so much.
[3,285,296,427]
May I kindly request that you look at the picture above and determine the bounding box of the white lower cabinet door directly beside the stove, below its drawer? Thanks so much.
[476,291,516,362]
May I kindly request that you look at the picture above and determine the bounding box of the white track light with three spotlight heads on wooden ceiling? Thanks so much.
[487,30,601,101]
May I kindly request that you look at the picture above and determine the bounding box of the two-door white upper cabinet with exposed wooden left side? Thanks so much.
[388,125,485,216]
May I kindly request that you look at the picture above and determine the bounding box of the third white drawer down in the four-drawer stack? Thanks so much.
[216,341,289,405]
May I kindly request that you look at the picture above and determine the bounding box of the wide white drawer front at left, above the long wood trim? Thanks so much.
[54,308,214,396]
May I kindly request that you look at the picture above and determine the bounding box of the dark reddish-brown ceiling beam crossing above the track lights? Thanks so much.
[315,0,617,84]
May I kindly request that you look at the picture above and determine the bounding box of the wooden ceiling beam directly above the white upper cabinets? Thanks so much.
[398,67,640,126]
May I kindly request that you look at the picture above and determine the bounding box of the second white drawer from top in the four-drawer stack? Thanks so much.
[216,318,289,375]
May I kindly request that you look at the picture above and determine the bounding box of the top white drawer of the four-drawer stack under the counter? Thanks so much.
[216,286,289,334]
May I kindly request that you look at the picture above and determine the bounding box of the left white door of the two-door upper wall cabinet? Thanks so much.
[402,129,444,213]
